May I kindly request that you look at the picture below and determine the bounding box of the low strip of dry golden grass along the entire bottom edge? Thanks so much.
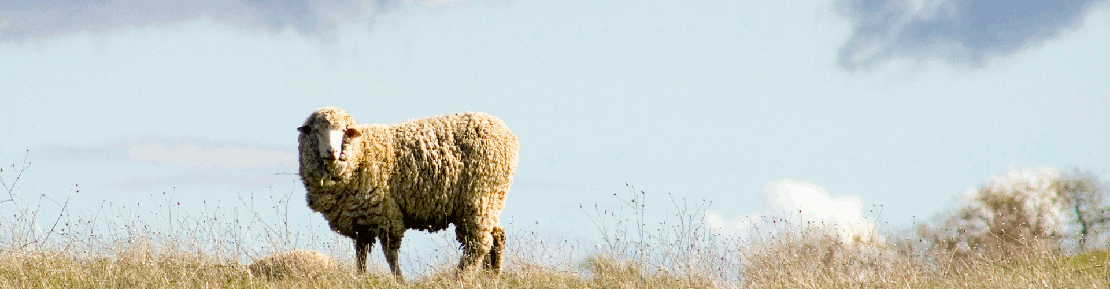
[0,223,1110,289]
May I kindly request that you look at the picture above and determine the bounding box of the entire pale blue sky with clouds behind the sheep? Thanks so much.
[0,0,1110,266]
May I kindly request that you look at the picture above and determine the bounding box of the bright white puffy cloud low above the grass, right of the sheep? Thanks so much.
[705,179,882,242]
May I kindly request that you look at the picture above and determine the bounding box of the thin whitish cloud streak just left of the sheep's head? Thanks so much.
[129,145,296,168]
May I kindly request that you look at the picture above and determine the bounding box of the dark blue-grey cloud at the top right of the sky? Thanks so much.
[837,0,1106,70]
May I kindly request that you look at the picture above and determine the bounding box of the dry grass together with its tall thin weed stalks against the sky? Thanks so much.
[0,156,1110,289]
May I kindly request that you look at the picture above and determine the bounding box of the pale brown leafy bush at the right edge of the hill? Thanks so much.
[918,168,1108,258]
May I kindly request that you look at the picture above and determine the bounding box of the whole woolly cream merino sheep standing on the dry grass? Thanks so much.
[297,107,519,278]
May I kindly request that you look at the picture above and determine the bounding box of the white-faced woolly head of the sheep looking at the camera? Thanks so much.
[296,107,362,179]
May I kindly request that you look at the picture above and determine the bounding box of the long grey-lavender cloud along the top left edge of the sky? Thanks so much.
[0,0,451,41]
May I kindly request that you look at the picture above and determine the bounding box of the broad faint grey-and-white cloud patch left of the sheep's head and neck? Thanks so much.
[30,138,297,191]
